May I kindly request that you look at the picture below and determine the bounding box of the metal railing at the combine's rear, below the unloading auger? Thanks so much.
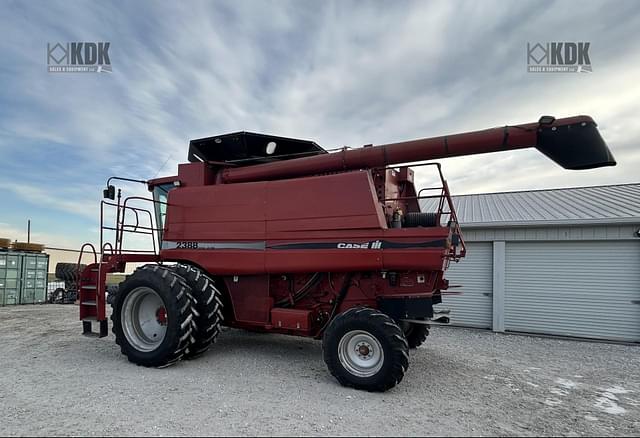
[382,163,467,263]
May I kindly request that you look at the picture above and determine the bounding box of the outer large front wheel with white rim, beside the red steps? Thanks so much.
[111,265,193,367]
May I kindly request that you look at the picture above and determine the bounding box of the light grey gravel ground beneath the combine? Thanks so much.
[0,305,640,436]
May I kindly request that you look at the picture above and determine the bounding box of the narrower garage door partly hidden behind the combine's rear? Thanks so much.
[436,242,493,328]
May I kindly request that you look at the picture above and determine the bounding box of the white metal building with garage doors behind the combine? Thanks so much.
[422,184,640,342]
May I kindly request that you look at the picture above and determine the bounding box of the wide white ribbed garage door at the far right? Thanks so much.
[505,241,640,342]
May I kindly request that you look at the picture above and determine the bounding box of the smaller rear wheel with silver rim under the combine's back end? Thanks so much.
[322,307,409,392]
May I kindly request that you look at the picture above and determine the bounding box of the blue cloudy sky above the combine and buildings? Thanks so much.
[0,0,640,248]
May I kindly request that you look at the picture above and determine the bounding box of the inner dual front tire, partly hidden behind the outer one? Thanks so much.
[174,264,223,359]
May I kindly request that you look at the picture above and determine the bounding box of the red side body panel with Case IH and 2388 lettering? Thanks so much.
[160,171,449,275]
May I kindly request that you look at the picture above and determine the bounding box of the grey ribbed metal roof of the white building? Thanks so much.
[421,183,640,227]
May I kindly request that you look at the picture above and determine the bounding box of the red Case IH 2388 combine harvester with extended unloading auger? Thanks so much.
[79,116,615,391]
